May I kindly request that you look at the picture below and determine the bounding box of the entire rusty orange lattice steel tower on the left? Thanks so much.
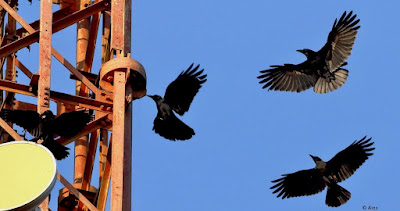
[0,0,146,211]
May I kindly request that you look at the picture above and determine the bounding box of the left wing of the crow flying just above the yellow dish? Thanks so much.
[0,109,42,137]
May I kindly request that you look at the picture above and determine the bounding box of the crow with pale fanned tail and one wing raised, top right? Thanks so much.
[257,11,360,93]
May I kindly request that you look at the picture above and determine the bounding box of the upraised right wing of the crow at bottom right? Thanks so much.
[326,136,375,182]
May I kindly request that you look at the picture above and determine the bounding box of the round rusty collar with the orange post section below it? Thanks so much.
[100,54,146,210]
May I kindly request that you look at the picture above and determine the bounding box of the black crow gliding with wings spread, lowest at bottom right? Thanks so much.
[271,137,375,207]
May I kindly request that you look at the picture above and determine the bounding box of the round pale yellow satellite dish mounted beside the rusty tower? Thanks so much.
[0,141,57,211]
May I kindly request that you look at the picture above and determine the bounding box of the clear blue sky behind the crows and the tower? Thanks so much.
[10,0,400,211]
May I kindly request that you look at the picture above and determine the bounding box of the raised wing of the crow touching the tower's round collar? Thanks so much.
[164,64,207,115]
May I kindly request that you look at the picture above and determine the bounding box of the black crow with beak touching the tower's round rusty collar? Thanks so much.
[148,64,207,141]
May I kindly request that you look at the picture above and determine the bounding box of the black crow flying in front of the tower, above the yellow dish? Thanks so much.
[0,110,92,160]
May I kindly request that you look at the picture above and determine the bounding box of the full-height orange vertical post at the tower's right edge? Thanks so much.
[109,0,136,210]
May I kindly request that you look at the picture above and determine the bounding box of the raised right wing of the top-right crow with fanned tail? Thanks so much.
[319,11,360,72]
